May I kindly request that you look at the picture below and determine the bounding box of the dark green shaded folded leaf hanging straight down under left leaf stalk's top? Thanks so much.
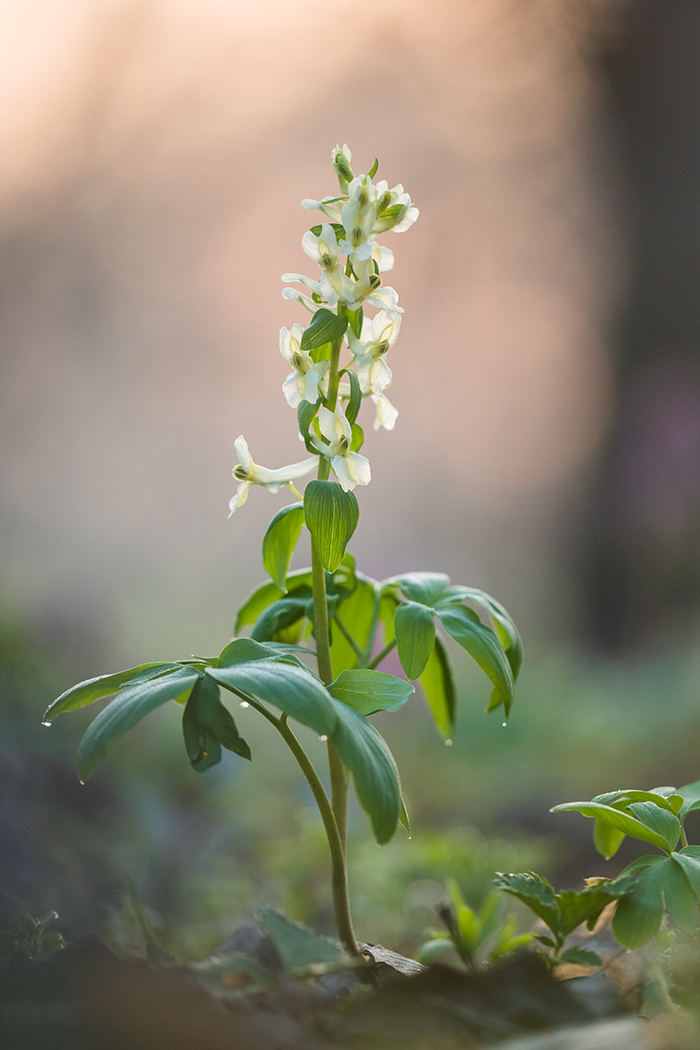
[183,675,251,773]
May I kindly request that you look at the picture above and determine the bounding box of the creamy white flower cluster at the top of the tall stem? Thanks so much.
[230,146,419,513]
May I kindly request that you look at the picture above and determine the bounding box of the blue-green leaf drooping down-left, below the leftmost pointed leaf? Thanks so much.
[78,667,200,783]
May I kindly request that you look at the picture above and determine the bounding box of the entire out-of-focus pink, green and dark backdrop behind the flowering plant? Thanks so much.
[0,0,700,954]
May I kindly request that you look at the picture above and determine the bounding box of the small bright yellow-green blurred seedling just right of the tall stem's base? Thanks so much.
[418,879,533,970]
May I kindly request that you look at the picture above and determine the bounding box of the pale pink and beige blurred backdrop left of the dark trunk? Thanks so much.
[0,0,625,673]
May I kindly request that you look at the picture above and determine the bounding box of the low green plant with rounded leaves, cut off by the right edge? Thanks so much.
[552,780,700,948]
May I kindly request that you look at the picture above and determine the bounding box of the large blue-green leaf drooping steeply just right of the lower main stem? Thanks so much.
[328,700,402,845]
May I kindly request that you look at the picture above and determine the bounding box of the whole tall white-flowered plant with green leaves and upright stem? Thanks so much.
[45,146,521,953]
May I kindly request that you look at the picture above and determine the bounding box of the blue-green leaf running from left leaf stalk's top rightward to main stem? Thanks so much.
[207,658,337,736]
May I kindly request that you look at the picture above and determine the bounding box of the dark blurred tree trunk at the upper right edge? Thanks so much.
[584,0,700,649]
